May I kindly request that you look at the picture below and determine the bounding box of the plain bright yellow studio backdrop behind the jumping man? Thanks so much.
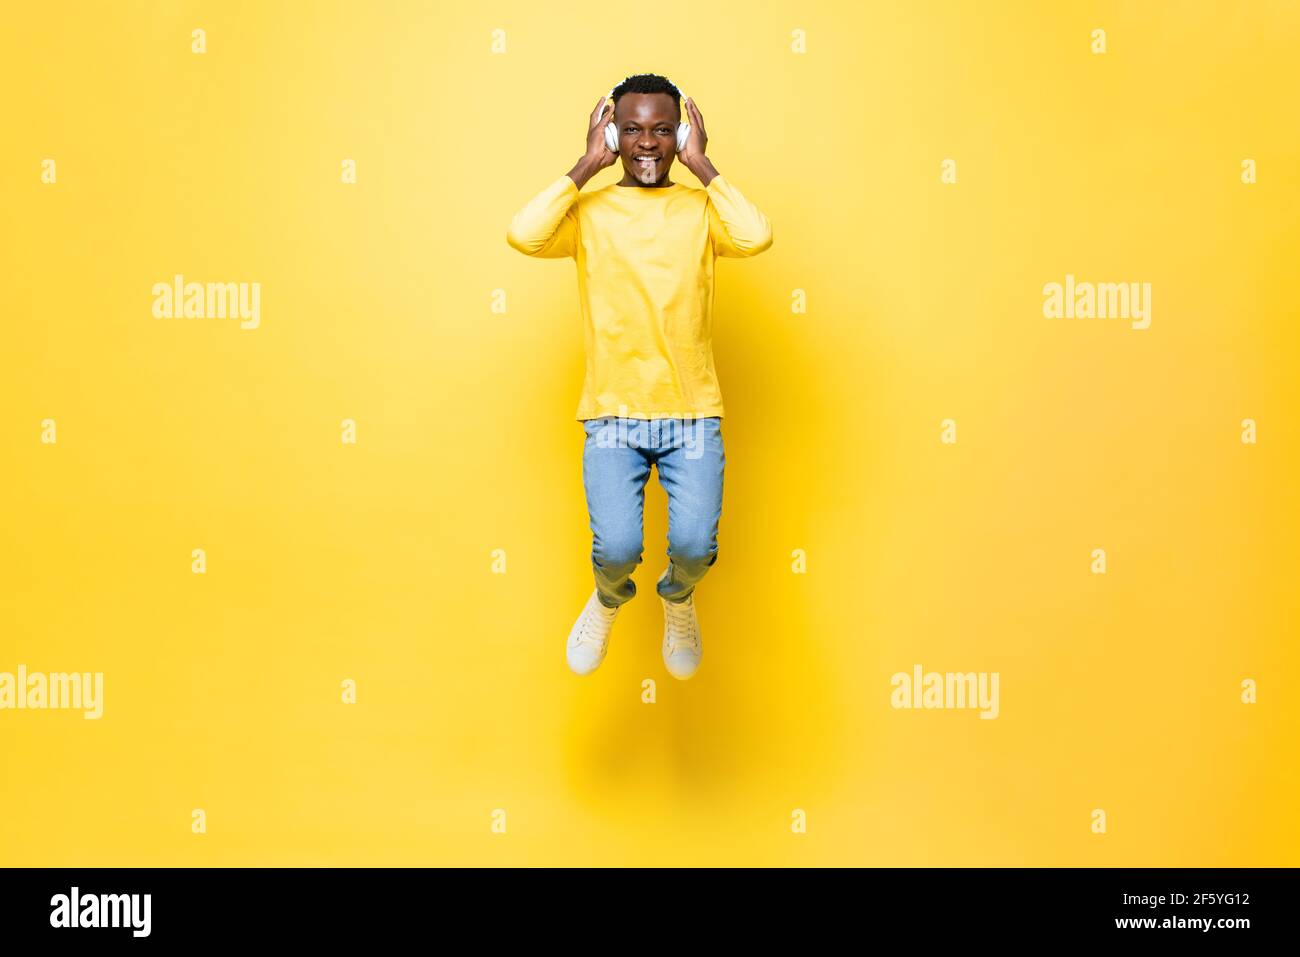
[0,0,1300,866]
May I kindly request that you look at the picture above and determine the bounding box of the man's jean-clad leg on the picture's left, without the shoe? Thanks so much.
[582,417,650,607]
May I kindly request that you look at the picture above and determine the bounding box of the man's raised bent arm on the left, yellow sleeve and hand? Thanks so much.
[506,96,619,259]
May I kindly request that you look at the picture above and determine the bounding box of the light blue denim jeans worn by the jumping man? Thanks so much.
[582,416,727,607]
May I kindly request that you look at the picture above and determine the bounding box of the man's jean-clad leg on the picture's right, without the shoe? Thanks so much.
[657,416,727,602]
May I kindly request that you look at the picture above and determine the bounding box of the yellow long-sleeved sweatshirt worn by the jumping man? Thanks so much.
[506,176,772,419]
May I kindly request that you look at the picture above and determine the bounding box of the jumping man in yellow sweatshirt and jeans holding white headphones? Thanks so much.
[507,74,772,679]
